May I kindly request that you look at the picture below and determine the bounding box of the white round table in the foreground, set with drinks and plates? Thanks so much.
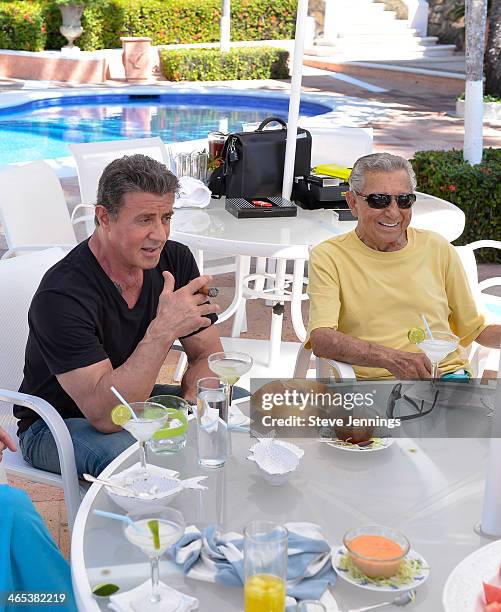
[71,402,487,612]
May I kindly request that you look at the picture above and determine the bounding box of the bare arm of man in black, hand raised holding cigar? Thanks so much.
[57,272,219,433]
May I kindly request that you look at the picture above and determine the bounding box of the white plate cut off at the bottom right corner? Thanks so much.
[442,540,501,612]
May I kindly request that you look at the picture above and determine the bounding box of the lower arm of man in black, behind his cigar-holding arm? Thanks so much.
[181,325,223,402]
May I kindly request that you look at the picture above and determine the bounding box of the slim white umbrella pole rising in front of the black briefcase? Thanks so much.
[282,0,308,199]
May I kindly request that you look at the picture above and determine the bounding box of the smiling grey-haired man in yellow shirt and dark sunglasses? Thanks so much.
[307,153,501,379]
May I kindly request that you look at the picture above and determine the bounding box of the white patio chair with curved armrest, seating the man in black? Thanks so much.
[0,248,80,532]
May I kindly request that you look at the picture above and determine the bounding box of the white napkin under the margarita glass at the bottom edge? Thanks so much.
[108,580,198,612]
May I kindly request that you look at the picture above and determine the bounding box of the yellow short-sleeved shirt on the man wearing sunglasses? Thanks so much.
[307,227,486,379]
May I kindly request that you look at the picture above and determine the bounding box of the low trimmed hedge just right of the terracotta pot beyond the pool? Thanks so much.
[160,47,289,81]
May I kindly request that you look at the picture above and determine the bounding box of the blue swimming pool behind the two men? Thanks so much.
[0,92,330,164]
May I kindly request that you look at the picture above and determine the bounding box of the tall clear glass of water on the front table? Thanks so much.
[197,377,229,468]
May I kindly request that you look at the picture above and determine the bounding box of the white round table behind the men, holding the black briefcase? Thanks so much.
[171,192,465,366]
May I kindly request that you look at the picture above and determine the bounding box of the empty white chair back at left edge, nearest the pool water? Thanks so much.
[0,161,89,259]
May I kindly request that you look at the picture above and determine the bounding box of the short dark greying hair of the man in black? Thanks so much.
[96,153,179,225]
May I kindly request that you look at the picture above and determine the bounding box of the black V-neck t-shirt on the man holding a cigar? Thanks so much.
[14,240,217,433]
